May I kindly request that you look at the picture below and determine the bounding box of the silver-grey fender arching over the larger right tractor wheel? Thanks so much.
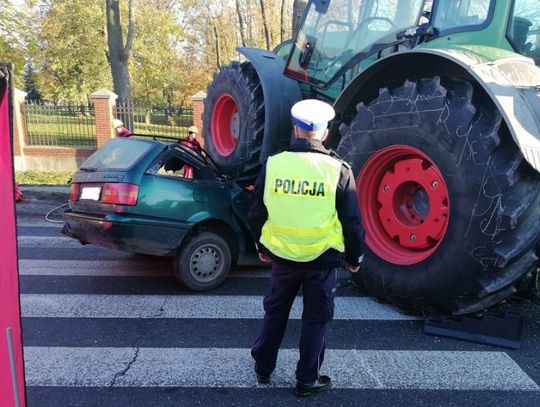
[334,48,540,172]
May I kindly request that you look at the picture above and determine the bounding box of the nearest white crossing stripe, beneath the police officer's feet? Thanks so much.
[24,347,540,391]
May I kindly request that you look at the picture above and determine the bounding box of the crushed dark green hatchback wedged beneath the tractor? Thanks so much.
[62,137,257,291]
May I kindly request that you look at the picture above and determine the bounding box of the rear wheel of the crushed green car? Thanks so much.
[173,232,231,291]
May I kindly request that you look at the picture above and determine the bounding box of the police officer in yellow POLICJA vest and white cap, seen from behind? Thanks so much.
[248,99,363,397]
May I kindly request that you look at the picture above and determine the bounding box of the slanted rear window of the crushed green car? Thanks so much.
[81,138,152,171]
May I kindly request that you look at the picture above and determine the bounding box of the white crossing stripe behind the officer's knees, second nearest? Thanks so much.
[21,294,419,321]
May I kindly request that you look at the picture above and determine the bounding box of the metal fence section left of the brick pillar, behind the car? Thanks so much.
[22,103,97,148]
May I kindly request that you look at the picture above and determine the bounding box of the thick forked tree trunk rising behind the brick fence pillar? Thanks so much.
[106,0,135,102]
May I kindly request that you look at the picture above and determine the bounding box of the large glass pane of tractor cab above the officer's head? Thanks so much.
[285,0,424,87]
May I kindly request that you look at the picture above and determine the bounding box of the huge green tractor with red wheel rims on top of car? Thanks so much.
[203,0,540,315]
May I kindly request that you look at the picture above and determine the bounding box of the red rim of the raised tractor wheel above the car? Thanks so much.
[211,93,240,157]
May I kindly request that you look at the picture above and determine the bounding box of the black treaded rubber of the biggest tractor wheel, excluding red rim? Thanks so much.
[338,77,540,314]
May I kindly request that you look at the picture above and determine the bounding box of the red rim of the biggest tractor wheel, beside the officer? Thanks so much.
[356,145,450,265]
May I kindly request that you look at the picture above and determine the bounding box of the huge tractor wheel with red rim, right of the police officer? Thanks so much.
[338,77,540,315]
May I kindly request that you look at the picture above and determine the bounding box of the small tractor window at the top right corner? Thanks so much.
[507,0,540,65]
